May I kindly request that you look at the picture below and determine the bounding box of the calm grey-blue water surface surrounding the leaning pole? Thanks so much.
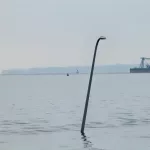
[0,74,150,150]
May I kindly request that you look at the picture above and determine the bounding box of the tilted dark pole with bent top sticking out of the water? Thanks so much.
[81,36,106,134]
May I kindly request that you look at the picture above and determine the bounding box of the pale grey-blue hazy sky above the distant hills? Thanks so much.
[0,0,150,70]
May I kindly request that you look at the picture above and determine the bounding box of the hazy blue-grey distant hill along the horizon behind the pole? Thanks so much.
[2,64,138,75]
